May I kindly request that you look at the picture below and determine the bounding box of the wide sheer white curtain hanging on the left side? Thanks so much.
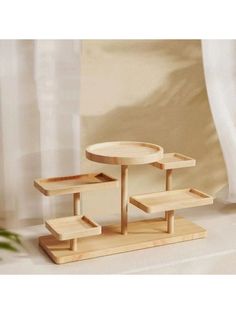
[0,40,80,224]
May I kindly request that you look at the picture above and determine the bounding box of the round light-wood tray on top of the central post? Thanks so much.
[86,141,163,165]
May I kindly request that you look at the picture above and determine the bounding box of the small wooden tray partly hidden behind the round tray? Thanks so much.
[152,153,196,170]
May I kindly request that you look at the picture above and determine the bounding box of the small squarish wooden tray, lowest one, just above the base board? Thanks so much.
[45,216,102,241]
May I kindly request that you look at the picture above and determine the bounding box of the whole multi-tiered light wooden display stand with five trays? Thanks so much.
[34,142,213,264]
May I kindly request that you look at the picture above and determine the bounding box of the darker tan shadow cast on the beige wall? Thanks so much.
[81,41,226,194]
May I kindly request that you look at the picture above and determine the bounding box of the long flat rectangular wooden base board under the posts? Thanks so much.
[39,217,206,264]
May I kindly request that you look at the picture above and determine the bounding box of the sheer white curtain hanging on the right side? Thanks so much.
[202,40,236,203]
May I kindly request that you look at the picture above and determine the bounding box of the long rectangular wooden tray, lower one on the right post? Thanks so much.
[130,188,213,213]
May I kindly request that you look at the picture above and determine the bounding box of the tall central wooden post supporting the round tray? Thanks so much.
[121,165,128,234]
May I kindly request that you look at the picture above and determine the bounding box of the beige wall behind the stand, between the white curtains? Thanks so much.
[81,40,226,218]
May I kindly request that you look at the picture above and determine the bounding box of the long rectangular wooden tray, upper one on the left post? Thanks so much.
[34,172,118,196]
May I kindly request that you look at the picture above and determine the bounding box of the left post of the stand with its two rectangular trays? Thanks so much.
[34,173,118,261]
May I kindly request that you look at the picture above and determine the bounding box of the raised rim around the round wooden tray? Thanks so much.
[85,141,163,165]
